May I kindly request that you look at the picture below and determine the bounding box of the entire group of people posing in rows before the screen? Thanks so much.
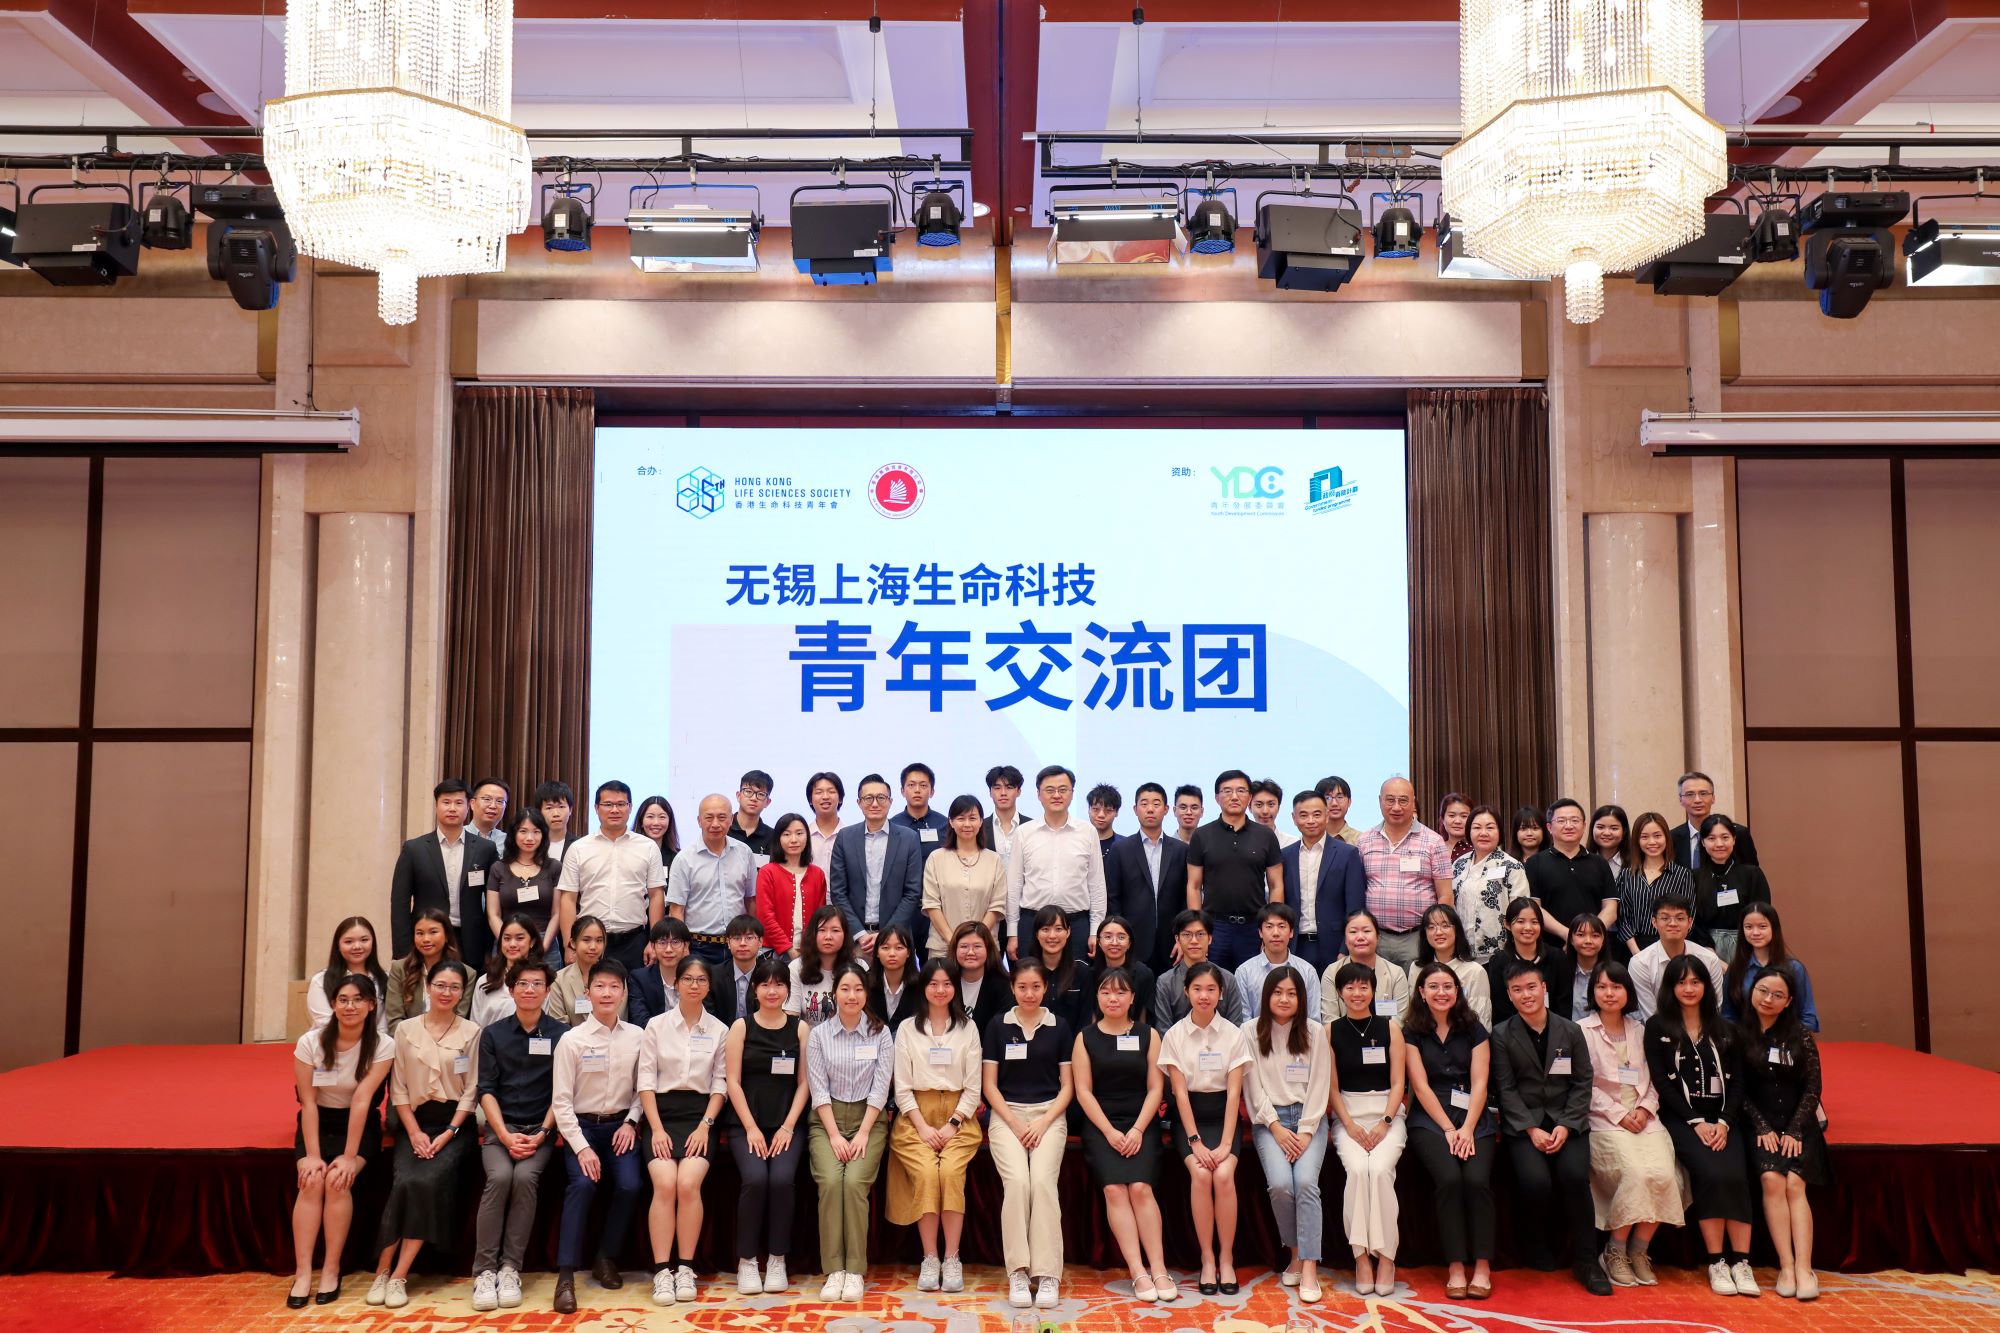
[290,765,1826,1313]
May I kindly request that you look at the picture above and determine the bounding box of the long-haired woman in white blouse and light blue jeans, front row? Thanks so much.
[1244,967,1334,1305]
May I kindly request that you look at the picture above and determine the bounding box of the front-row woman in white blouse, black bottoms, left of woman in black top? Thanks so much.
[638,953,730,1305]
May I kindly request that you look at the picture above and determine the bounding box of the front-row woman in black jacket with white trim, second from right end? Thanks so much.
[1646,953,1758,1297]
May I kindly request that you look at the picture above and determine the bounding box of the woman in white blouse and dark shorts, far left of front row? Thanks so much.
[286,972,396,1309]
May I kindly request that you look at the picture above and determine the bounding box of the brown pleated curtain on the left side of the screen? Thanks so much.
[444,378,596,837]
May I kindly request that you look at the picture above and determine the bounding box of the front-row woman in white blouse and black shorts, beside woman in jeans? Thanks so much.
[1160,963,1248,1295]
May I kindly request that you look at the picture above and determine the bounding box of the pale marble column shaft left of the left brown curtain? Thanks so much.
[304,514,410,975]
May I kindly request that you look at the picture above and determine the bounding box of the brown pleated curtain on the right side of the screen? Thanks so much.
[1410,388,1556,820]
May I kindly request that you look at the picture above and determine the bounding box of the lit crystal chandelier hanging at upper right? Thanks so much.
[1444,0,1728,324]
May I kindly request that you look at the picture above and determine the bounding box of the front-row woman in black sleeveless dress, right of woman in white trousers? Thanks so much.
[1070,967,1180,1301]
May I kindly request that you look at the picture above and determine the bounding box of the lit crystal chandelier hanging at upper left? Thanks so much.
[264,0,532,324]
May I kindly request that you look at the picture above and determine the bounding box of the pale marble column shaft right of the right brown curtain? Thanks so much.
[1584,512,1686,817]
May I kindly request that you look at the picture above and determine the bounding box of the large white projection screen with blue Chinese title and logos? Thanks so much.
[586,426,1410,843]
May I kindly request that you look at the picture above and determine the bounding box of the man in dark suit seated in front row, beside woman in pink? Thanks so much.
[1492,959,1612,1295]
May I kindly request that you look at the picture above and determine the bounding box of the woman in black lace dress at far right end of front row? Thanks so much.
[1740,967,1828,1301]
